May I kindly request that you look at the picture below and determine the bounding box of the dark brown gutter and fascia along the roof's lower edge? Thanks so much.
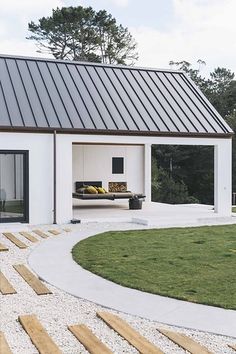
[0,126,234,139]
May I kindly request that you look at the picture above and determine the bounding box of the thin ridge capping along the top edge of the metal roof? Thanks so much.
[0,54,184,74]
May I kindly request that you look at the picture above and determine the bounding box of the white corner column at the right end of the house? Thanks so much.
[214,139,232,216]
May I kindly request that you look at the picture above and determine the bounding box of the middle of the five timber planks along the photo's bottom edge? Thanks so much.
[68,324,112,354]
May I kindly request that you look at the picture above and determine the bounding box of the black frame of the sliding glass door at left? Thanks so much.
[0,150,29,223]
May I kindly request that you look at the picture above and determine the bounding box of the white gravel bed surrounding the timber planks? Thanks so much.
[0,224,236,354]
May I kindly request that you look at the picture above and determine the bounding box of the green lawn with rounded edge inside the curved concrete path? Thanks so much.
[72,225,236,309]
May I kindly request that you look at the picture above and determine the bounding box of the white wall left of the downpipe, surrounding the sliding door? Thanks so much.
[0,133,53,224]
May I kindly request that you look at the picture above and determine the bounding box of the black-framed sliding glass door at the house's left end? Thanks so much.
[0,150,29,223]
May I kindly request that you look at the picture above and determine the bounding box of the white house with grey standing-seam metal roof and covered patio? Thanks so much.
[0,55,233,224]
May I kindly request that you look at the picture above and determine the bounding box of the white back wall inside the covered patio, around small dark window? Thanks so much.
[72,145,144,193]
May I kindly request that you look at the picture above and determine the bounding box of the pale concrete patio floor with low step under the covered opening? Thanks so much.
[73,200,236,227]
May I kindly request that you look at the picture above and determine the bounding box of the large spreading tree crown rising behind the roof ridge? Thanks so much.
[27,6,138,65]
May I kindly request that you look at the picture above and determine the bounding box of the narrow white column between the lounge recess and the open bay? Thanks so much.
[144,144,152,202]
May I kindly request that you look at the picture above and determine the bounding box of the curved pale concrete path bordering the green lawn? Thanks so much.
[28,226,236,337]
